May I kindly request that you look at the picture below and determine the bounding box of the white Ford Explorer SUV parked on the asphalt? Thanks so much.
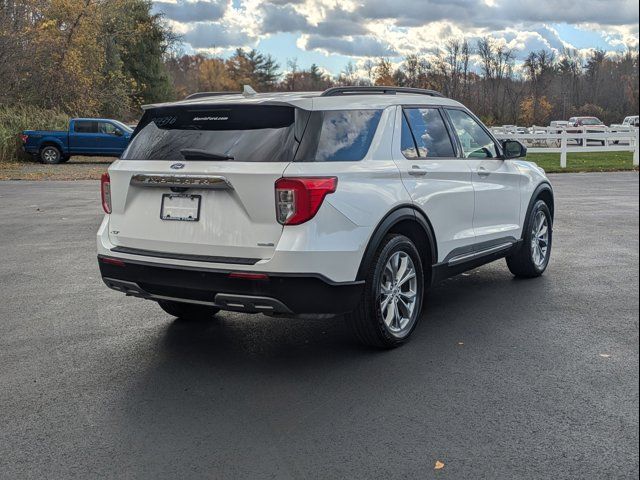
[97,87,554,347]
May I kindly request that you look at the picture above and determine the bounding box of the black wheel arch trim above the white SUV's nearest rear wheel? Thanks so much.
[356,205,438,285]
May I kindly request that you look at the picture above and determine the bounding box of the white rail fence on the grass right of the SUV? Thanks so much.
[491,127,640,168]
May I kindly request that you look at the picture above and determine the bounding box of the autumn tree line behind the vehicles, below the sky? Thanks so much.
[0,0,639,125]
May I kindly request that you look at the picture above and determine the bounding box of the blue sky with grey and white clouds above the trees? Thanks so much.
[153,0,638,75]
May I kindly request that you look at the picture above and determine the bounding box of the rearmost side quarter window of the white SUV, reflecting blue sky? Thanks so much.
[296,110,382,162]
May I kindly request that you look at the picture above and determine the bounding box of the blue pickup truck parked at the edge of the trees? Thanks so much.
[20,118,133,163]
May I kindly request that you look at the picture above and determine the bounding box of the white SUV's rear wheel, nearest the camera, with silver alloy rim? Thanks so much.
[346,234,424,348]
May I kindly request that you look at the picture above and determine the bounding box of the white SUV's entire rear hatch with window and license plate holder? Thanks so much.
[109,104,298,264]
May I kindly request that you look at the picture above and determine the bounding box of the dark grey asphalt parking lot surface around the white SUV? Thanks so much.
[0,173,638,479]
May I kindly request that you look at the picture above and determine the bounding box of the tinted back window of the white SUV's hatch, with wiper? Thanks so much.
[122,105,297,162]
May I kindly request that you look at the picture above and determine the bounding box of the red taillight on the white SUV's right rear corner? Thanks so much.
[276,177,338,225]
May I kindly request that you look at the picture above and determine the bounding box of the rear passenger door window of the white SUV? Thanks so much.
[401,108,456,158]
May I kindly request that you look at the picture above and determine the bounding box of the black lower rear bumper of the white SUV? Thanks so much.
[98,255,364,315]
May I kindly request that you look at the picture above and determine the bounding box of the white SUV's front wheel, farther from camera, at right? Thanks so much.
[507,200,553,278]
